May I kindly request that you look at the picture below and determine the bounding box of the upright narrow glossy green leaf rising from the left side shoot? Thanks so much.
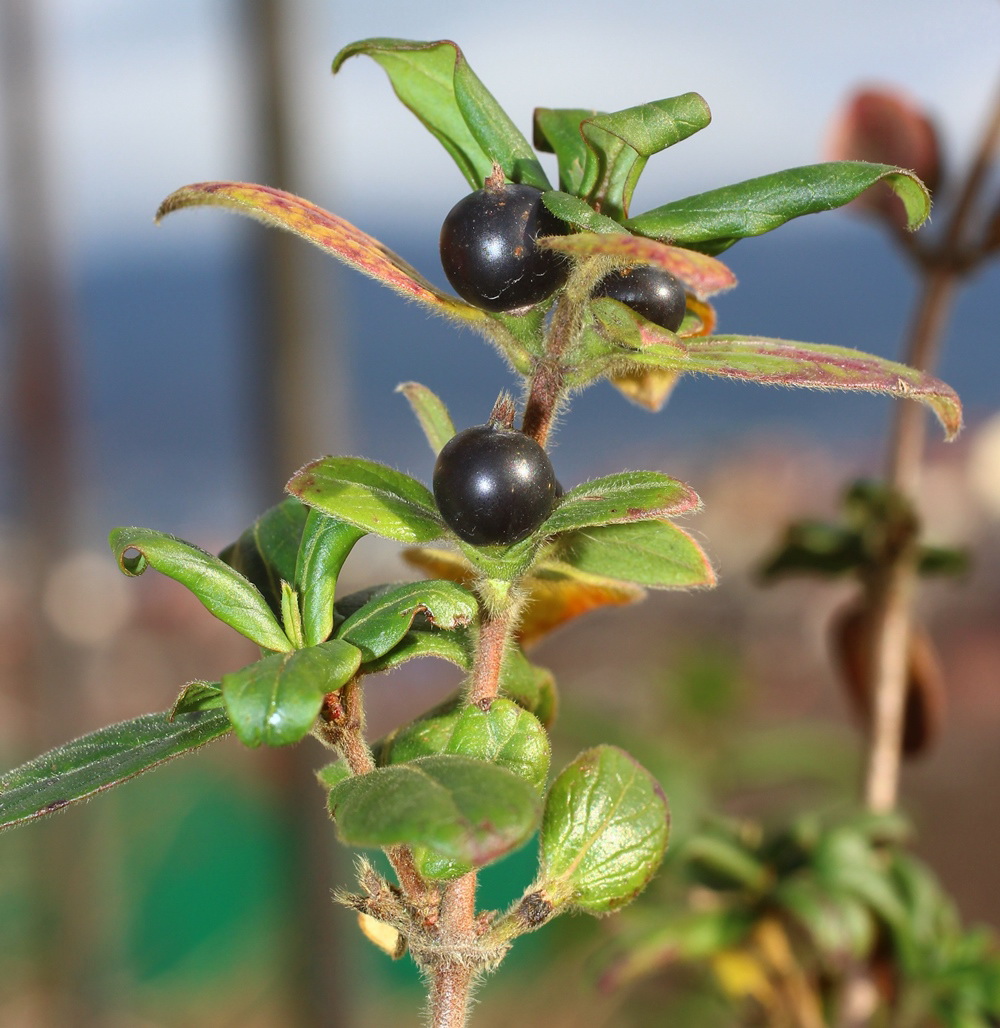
[294,507,365,646]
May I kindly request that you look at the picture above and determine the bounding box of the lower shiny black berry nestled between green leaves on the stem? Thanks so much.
[434,425,557,546]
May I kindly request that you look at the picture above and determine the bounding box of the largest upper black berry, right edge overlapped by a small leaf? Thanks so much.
[441,183,569,311]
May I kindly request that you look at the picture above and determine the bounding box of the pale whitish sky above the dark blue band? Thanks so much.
[11,0,1000,249]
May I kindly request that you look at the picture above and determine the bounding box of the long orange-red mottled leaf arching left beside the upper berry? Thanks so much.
[156,182,488,325]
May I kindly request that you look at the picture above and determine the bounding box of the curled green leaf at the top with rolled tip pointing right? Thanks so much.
[580,93,712,218]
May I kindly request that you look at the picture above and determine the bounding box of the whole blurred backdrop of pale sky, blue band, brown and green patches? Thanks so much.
[0,0,1000,1028]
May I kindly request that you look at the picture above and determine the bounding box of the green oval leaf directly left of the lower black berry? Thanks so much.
[286,456,444,543]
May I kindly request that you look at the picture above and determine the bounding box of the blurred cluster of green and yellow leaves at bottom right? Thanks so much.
[602,813,1000,1028]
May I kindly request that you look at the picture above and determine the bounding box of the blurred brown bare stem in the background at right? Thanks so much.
[864,80,1000,812]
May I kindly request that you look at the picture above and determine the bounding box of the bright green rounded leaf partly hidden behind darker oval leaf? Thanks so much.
[385,697,551,790]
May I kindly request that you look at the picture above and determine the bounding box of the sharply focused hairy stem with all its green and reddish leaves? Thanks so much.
[0,39,961,1026]
